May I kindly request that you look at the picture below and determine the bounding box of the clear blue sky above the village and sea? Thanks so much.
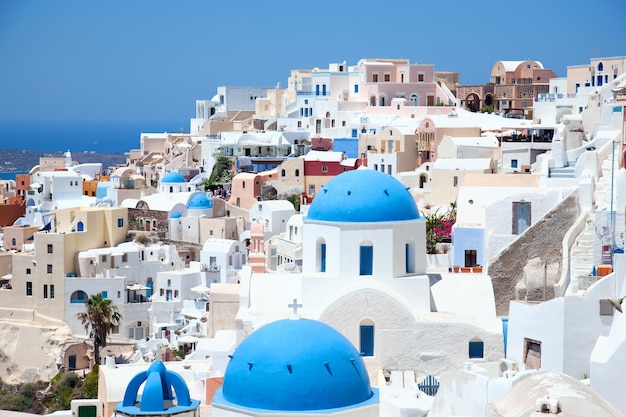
[0,0,626,121]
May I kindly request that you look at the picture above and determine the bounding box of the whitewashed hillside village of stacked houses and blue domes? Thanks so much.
[0,57,626,417]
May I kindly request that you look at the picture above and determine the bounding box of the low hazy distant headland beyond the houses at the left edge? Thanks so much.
[0,148,126,172]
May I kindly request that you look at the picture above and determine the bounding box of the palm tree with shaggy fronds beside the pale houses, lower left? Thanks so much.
[76,293,122,365]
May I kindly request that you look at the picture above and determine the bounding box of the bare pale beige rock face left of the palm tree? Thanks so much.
[0,322,73,384]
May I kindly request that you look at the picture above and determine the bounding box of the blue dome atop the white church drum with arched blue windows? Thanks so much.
[307,169,420,223]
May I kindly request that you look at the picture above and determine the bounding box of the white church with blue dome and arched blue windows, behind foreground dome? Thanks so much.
[238,168,504,381]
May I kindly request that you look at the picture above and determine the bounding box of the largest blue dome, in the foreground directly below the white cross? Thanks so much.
[222,319,373,411]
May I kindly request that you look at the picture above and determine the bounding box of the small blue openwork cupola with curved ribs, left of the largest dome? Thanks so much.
[115,360,200,416]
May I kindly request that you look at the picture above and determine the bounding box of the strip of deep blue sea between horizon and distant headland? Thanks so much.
[0,120,189,154]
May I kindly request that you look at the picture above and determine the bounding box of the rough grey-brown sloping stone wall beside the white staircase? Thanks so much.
[489,190,580,316]
